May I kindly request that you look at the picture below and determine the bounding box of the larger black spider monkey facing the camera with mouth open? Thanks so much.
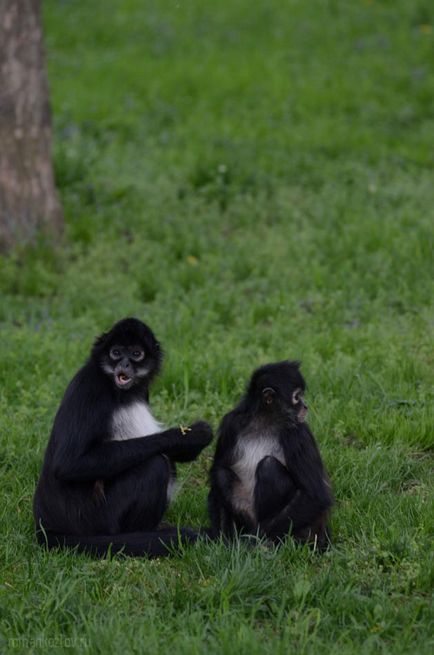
[34,318,212,557]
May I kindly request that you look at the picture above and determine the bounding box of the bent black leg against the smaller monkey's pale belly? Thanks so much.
[255,457,297,523]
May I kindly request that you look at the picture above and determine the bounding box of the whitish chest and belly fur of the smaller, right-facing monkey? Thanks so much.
[232,433,285,521]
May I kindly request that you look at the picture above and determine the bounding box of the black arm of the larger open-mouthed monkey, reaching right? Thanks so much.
[52,423,212,482]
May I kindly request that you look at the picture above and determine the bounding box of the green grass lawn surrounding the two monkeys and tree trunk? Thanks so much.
[0,0,434,655]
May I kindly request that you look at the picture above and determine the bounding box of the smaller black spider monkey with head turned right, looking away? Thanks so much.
[208,361,333,550]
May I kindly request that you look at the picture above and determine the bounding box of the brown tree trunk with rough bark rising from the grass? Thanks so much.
[0,0,63,250]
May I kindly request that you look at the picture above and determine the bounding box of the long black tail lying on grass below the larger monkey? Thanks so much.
[36,527,209,558]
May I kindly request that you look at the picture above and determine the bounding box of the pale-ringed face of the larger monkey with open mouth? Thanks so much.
[102,344,149,391]
